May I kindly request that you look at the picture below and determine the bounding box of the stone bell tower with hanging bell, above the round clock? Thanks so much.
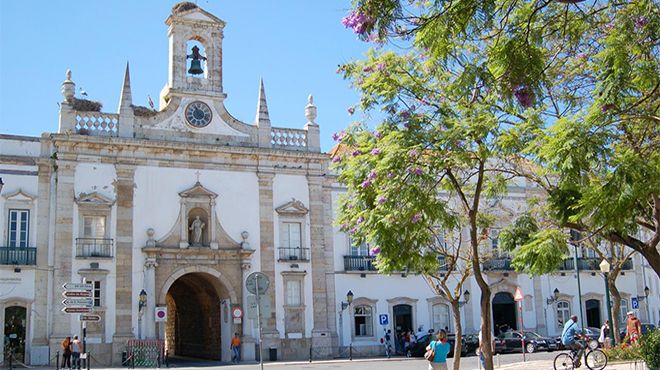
[161,2,226,101]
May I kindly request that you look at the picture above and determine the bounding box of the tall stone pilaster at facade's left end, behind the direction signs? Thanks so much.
[51,158,76,340]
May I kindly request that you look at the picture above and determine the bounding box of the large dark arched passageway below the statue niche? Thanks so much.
[165,272,231,361]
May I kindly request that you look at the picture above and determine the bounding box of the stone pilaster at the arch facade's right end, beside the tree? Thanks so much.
[307,175,332,357]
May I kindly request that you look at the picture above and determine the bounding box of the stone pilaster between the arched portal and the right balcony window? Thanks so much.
[256,172,277,332]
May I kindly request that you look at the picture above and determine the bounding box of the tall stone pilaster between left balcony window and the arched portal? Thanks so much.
[112,164,137,365]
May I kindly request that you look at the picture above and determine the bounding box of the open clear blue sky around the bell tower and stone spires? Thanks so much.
[0,0,369,151]
